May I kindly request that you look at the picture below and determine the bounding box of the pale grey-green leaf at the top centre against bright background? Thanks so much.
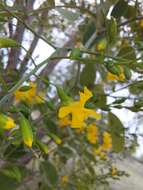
[56,8,80,21]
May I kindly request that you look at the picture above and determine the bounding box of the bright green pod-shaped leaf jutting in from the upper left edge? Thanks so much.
[0,38,20,48]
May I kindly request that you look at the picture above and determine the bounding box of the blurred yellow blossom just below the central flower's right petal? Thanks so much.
[87,125,98,144]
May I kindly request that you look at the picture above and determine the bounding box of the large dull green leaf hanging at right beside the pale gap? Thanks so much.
[108,112,125,152]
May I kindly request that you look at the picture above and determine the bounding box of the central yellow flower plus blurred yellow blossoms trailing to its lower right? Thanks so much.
[58,87,112,159]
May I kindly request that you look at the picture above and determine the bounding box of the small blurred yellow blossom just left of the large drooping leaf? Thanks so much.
[102,132,112,151]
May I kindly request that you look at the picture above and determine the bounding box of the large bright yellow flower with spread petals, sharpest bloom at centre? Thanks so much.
[58,87,101,128]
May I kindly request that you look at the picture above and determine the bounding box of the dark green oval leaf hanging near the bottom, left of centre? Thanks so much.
[40,161,58,186]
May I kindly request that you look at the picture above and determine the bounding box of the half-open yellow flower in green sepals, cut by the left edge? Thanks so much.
[0,114,16,129]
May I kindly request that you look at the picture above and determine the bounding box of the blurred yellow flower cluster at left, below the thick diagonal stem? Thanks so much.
[14,82,44,104]
